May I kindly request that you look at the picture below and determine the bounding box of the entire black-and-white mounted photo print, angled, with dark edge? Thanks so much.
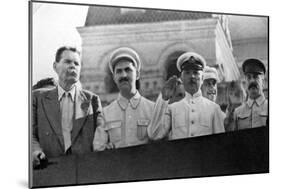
[28,1,270,188]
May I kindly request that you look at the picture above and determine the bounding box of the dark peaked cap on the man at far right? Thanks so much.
[242,59,266,74]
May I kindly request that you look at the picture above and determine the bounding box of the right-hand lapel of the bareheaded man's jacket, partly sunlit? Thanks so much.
[71,88,93,144]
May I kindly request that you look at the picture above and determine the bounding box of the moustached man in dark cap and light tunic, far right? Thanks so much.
[233,59,268,130]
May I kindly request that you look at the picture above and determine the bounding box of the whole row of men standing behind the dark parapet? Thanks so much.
[31,47,268,167]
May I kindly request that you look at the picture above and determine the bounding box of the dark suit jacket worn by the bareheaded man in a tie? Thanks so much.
[32,87,101,157]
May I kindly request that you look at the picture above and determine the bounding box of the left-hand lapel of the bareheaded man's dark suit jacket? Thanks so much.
[43,88,64,149]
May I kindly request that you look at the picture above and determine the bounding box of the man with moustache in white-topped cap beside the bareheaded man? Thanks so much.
[94,47,154,151]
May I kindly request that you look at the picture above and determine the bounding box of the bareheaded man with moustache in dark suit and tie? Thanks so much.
[32,47,102,165]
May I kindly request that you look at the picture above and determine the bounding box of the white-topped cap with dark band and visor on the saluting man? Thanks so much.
[177,52,206,72]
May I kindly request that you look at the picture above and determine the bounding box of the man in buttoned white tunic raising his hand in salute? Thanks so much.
[148,52,224,140]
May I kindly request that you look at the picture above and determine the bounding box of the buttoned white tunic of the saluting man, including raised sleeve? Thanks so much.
[148,91,224,140]
